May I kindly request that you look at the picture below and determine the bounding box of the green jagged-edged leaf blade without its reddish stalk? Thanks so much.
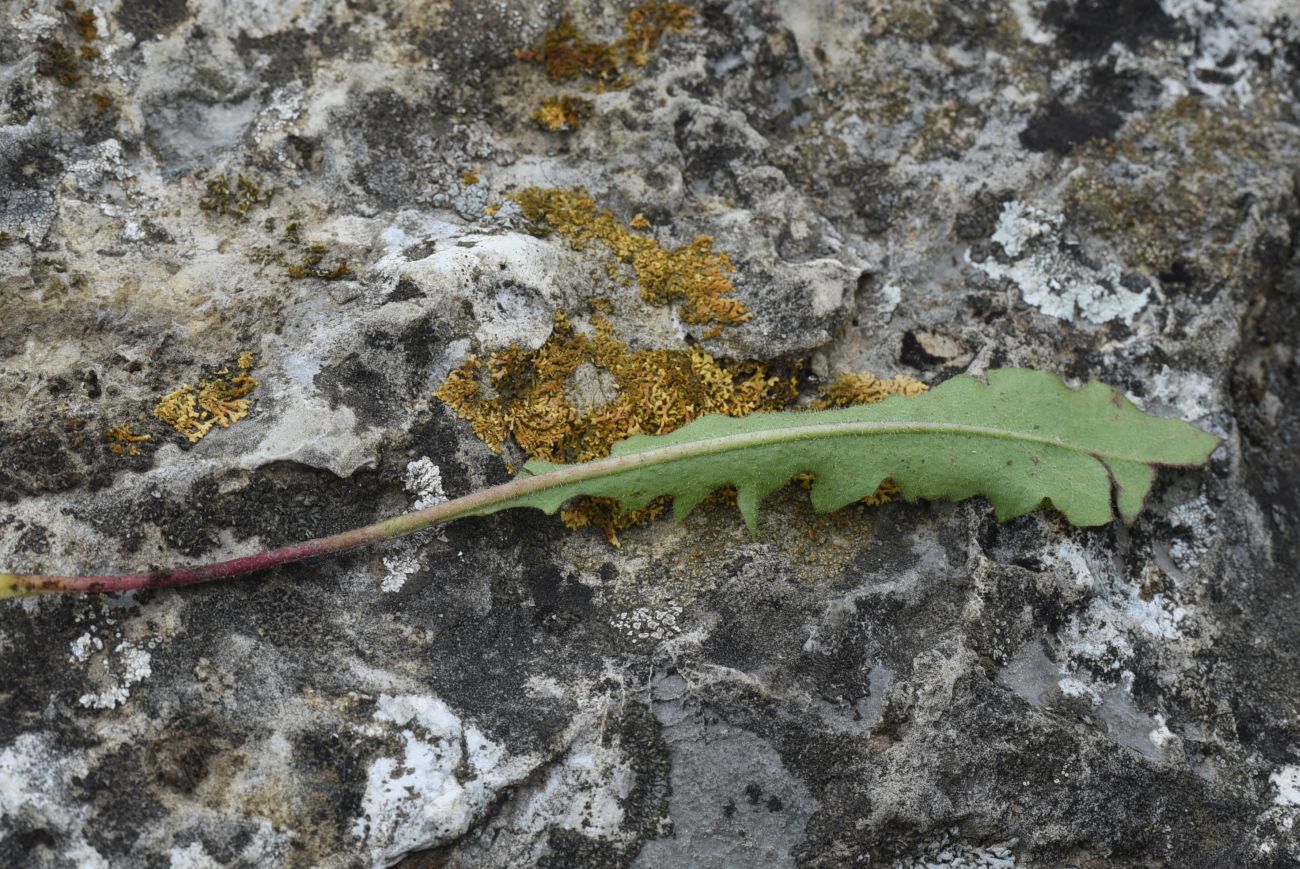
[478,368,1219,532]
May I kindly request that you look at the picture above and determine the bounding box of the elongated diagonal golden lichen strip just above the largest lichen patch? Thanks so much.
[515,187,750,325]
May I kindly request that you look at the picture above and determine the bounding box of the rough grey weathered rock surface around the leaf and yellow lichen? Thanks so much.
[0,0,1300,868]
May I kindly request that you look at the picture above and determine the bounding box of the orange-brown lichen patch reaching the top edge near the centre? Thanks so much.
[515,0,696,90]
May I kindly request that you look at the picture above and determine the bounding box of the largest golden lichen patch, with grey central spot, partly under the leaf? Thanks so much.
[437,312,794,545]
